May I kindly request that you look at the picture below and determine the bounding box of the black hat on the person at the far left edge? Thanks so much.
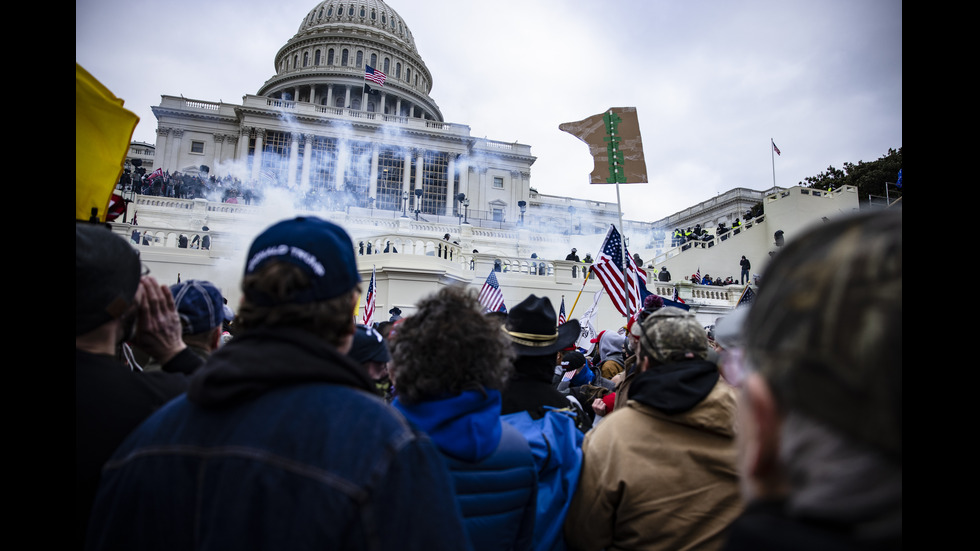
[75,222,140,336]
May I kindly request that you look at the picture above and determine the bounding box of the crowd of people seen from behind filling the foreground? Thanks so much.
[75,210,902,551]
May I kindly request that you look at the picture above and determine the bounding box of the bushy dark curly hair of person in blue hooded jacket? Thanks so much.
[389,286,514,404]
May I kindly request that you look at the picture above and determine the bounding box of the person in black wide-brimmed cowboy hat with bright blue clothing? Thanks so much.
[501,295,590,551]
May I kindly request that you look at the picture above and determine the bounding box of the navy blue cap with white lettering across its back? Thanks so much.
[245,216,361,306]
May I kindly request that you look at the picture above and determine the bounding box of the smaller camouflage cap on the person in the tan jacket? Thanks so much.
[640,306,708,363]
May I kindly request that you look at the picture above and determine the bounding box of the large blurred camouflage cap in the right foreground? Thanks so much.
[744,209,902,462]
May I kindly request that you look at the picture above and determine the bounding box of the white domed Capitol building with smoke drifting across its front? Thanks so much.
[113,0,858,330]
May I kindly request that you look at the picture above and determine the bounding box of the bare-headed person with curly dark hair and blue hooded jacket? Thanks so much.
[391,286,537,551]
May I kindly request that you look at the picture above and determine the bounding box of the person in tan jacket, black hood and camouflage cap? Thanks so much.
[565,307,742,551]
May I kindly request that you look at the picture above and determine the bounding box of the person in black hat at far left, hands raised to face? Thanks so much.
[75,222,201,547]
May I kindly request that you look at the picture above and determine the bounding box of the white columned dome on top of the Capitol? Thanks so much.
[258,0,443,121]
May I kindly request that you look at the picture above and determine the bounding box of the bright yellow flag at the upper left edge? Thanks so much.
[75,63,139,222]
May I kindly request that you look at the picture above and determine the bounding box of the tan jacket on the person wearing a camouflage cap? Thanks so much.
[564,379,742,551]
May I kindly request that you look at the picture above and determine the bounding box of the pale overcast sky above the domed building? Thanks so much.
[75,0,902,221]
